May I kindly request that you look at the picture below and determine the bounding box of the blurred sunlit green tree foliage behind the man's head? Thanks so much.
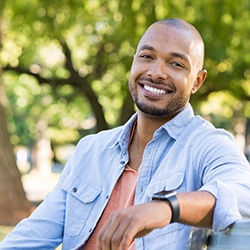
[0,0,250,144]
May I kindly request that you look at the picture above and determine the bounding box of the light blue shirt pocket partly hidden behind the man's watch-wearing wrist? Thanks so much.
[146,171,186,237]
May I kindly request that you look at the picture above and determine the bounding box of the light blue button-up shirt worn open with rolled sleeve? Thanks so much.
[0,105,250,250]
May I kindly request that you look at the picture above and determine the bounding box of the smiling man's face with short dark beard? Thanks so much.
[129,24,204,119]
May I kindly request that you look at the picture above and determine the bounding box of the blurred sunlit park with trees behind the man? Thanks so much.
[0,0,250,240]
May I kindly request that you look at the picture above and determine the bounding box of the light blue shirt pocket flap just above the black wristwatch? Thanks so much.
[146,171,185,198]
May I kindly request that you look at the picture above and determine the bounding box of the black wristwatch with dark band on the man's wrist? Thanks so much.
[152,190,180,223]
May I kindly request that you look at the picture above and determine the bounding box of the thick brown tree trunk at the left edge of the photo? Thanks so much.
[0,16,32,225]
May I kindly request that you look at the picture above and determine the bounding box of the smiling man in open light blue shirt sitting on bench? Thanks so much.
[0,19,250,250]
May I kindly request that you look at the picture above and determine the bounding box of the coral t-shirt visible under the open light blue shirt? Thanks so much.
[82,165,138,250]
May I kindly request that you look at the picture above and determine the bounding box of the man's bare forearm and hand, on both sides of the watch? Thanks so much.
[98,191,216,250]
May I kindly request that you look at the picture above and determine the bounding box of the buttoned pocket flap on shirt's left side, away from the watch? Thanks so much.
[62,174,102,203]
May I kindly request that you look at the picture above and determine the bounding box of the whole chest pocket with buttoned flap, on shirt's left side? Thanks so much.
[62,174,102,236]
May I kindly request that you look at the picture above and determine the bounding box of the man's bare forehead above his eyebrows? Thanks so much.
[137,24,195,54]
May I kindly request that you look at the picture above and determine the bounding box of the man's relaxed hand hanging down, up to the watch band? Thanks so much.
[97,200,172,250]
